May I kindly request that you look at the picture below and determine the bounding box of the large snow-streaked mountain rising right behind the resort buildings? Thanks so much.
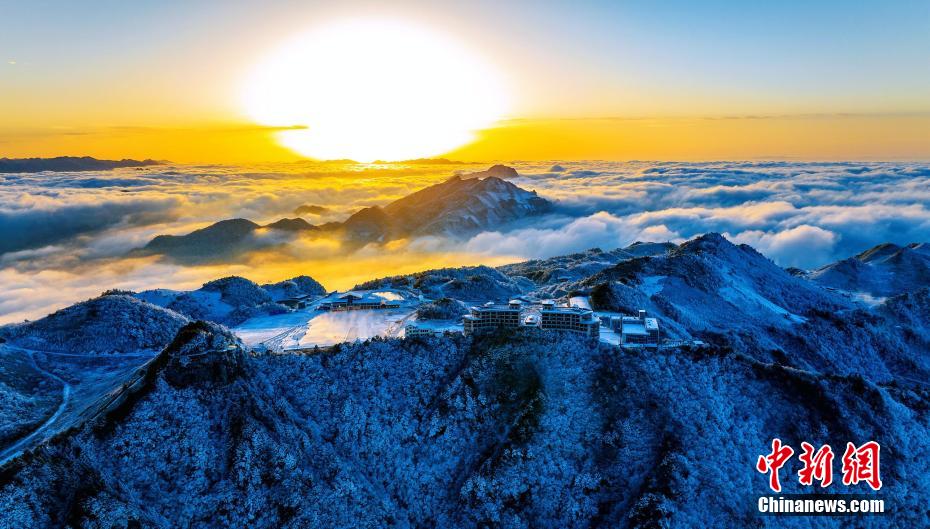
[571,234,930,381]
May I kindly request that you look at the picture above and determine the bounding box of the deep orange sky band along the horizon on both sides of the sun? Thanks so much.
[0,114,930,163]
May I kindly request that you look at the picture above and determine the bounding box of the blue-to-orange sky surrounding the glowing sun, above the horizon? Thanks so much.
[0,0,930,163]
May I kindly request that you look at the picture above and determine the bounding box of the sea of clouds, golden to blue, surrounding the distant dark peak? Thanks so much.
[0,161,930,322]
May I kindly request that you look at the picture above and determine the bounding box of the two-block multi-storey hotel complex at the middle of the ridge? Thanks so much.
[462,299,601,339]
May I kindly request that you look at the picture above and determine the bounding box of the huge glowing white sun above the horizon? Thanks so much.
[242,20,507,162]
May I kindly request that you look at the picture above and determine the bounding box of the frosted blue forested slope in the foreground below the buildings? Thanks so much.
[0,312,930,528]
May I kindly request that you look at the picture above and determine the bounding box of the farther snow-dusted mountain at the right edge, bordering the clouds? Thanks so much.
[809,243,930,298]
